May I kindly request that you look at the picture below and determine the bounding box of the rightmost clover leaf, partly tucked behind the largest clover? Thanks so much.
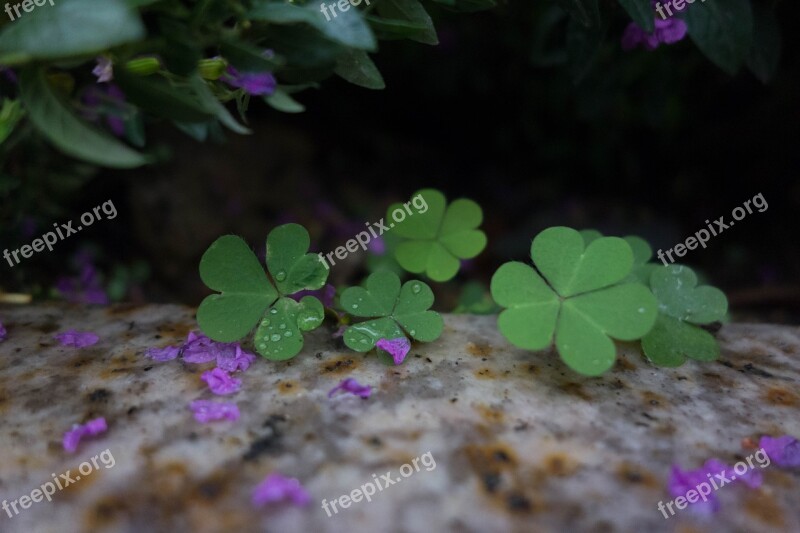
[642,265,728,367]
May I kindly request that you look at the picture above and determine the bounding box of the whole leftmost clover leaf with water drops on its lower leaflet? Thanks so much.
[197,224,328,360]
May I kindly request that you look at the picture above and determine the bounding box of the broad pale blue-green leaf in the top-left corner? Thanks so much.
[0,0,145,66]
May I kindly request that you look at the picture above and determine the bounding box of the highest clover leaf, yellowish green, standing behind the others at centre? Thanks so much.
[387,189,486,281]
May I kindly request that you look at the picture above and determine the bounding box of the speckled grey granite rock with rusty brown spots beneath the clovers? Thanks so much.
[0,306,800,533]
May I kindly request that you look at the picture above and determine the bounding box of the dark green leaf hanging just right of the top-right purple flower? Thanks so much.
[686,0,753,75]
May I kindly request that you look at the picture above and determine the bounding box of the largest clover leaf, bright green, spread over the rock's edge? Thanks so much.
[491,227,657,376]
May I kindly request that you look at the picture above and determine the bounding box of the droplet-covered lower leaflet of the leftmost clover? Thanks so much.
[253,296,325,361]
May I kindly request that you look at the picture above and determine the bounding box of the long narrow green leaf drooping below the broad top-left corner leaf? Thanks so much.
[19,68,147,168]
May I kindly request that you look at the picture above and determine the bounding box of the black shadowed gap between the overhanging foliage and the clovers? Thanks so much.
[3,2,800,322]
